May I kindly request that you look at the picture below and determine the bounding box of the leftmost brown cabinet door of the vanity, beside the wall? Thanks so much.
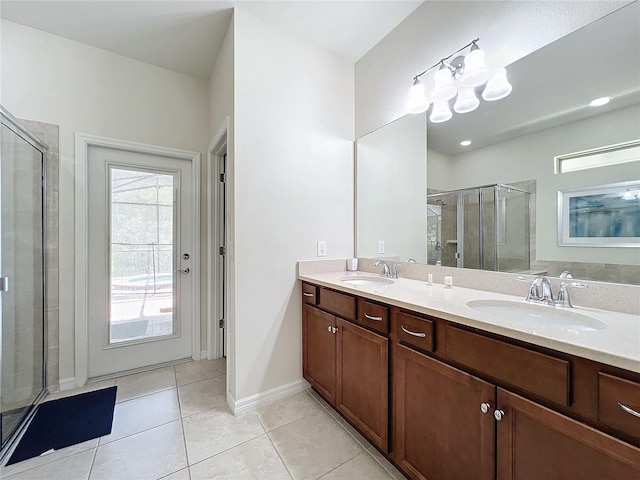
[302,305,336,404]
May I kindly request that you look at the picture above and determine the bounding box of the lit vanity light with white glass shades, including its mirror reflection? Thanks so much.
[407,38,512,123]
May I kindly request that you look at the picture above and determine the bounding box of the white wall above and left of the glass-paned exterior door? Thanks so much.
[0,20,209,380]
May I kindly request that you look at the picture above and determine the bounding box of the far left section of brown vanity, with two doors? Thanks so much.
[302,284,389,452]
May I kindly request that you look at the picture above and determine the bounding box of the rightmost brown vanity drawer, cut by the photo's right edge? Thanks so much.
[598,372,640,438]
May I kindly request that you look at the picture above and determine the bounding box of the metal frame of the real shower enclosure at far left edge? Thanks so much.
[0,105,49,460]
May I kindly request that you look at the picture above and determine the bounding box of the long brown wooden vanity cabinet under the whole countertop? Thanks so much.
[303,280,640,480]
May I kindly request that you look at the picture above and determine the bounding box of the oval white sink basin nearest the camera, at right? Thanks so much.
[467,300,607,332]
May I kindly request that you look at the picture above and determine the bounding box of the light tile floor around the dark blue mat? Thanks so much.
[0,360,404,480]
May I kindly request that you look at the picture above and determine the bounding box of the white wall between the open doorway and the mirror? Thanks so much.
[230,9,354,400]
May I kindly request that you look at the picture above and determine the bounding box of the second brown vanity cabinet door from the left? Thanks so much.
[336,318,389,452]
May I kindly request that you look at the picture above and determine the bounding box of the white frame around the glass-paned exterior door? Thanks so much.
[74,133,200,387]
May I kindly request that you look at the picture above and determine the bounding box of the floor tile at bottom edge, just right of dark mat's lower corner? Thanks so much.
[89,420,187,480]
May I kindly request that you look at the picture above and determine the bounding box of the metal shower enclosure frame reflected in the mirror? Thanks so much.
[427,183,531,271]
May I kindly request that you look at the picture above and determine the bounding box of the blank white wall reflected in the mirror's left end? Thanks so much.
[356,115,427,263]
